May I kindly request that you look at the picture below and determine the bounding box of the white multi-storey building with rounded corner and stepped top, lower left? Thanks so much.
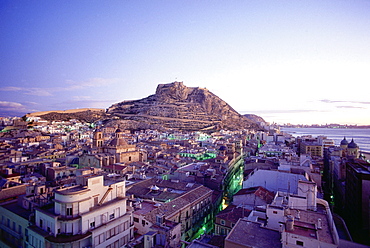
[29,175,133,248]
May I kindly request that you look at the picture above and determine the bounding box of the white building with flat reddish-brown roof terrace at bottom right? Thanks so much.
[266,181,339,248]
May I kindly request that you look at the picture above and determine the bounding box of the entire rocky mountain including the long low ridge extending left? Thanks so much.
[25,82,264,131]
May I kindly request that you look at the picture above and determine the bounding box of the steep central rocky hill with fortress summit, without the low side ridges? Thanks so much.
[107,82,258,130]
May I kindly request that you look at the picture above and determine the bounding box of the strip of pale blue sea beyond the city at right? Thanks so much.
[280,127,370,152]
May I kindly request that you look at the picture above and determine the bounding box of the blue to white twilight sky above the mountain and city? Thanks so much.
[0,0,370,125]
